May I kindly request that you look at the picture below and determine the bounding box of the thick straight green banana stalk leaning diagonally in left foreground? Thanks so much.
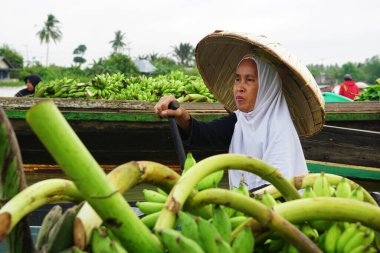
[26,100,163,253]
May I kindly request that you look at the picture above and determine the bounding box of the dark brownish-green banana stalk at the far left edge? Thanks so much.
[0,108,34,253]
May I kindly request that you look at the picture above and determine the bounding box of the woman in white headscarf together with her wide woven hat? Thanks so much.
[154,31,325,191]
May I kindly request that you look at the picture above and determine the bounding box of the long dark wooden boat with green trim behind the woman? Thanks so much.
[0,98,380,180]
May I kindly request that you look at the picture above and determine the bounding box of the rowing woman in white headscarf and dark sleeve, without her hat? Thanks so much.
[154,56,308,190]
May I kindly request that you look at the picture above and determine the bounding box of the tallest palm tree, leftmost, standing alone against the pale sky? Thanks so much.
[36,14,62,66]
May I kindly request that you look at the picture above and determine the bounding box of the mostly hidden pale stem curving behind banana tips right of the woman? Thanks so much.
[252,173,377,206]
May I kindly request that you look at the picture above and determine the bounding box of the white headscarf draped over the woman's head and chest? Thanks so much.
[229,57,308,189]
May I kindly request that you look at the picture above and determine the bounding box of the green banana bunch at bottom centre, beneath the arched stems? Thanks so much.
[156,206,255,253]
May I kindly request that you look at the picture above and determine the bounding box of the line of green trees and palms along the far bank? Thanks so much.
[0,14,380,85]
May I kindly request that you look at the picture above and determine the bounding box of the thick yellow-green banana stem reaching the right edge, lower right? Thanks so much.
[273,197,380,232]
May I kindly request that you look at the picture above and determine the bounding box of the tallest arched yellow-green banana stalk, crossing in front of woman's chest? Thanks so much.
[155,154,300,229]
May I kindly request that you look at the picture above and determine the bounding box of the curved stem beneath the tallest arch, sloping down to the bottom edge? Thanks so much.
[191,189,322,252]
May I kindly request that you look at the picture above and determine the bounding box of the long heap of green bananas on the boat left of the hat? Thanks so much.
[34,71,216,102]
